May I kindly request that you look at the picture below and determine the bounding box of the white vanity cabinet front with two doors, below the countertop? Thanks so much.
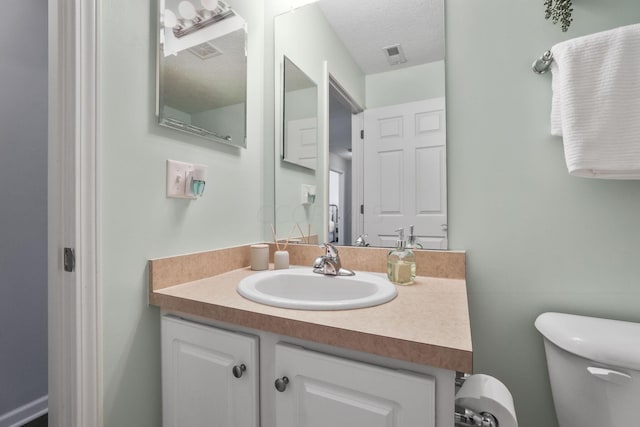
[162,315,455,427]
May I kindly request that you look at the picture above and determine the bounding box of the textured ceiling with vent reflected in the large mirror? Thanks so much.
[318,0,445,74]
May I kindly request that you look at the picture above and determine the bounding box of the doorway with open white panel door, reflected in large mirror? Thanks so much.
[327,80,447,249]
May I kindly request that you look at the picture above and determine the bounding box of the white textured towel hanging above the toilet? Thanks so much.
[551,24,640,179]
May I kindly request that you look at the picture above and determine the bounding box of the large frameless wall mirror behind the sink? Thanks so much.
[274,0,447,249]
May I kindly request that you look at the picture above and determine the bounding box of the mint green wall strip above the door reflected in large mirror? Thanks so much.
[365,61,445,108]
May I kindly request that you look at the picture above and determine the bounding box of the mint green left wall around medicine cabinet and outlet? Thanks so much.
[100,0,264,427]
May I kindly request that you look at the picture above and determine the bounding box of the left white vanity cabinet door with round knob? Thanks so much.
[162,316,259,427]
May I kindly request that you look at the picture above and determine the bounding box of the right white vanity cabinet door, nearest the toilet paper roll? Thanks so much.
[274,344,435,427]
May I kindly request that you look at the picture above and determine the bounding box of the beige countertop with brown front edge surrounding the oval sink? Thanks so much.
[149,267,473,373]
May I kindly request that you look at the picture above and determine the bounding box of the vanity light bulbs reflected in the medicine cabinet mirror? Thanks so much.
[163,0,235,38]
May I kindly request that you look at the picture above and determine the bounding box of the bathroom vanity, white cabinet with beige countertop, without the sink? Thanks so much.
[149,244,472,427]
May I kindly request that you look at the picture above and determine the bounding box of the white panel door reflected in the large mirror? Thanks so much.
[363,98,447,249]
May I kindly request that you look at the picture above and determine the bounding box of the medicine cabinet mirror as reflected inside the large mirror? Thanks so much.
[282,57,318,170]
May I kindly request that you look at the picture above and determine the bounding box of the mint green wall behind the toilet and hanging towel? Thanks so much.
[446,0,640,427]
